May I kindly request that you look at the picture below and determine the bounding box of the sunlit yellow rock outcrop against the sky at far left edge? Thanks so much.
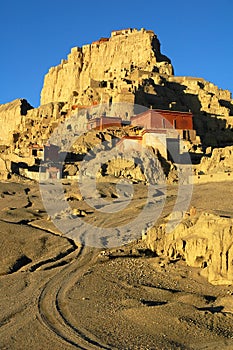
[0,99,33,145]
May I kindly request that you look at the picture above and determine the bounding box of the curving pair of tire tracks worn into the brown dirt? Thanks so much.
[38,247,111,350]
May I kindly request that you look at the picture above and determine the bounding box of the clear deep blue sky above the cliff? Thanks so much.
[0,0,233,107]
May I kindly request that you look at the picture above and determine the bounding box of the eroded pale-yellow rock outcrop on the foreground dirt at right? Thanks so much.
[143,210,233,285]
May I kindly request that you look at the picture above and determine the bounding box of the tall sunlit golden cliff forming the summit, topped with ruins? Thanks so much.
[41,29,173,105]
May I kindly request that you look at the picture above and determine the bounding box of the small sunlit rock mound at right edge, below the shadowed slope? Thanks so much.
[197,146,233,174]
